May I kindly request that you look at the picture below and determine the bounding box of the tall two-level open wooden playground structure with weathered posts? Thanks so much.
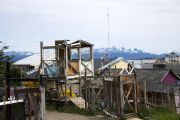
[39,40,94,102]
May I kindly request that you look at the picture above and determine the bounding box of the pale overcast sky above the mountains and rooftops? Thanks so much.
[0,0,180,53]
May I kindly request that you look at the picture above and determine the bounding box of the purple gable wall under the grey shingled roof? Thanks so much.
[162,72,177,84]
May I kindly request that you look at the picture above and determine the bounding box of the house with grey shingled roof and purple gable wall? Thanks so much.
[135,69,180,113]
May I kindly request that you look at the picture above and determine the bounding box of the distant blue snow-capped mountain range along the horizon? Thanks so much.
[5,47,165,62]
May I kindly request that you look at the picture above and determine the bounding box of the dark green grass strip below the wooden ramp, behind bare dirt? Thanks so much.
[46,102,95,116]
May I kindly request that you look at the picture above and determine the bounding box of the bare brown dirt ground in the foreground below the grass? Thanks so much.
[46,111,113,120]
